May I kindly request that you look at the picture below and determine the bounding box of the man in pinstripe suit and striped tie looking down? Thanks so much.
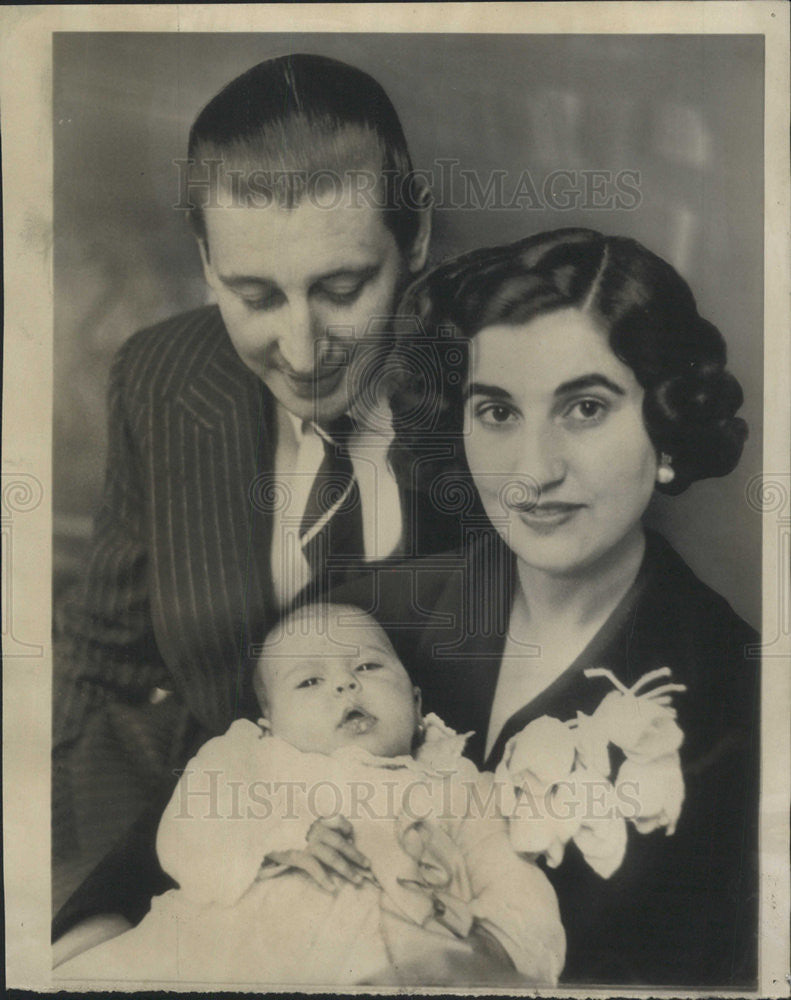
[53,55,452,920]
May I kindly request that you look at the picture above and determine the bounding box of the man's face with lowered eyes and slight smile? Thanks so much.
[201,188,422,423]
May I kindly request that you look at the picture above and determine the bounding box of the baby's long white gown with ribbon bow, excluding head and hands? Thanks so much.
[54,716,565,988]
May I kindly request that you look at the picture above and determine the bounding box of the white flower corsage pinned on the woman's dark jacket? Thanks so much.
[502,667,686,878]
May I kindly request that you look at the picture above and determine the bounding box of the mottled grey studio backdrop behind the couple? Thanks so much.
[53,33,763,625]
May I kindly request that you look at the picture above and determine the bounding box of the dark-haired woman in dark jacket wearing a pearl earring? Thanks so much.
[363,229,759,987]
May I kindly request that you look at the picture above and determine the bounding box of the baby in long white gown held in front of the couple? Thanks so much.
[57,605,565,987]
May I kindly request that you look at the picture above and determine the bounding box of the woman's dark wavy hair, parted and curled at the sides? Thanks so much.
[393,229,747,494]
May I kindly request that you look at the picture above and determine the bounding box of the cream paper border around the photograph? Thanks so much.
[0,0,791,997]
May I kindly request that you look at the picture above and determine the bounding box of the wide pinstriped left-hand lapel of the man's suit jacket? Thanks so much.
[154,313,277,730]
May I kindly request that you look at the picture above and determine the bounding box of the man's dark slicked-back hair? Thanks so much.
[188,54,425,253]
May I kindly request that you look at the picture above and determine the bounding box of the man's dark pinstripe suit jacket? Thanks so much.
[53,307,458,891]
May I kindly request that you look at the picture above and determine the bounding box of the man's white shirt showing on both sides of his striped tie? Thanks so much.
[271,405,402,608]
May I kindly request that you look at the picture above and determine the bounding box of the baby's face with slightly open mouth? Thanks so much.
[257,621,420,757]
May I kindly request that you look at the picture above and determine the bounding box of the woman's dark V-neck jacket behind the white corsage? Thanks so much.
[337,531,760,987]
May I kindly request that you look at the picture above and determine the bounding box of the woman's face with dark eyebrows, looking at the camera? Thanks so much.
[465,309,657,575]
